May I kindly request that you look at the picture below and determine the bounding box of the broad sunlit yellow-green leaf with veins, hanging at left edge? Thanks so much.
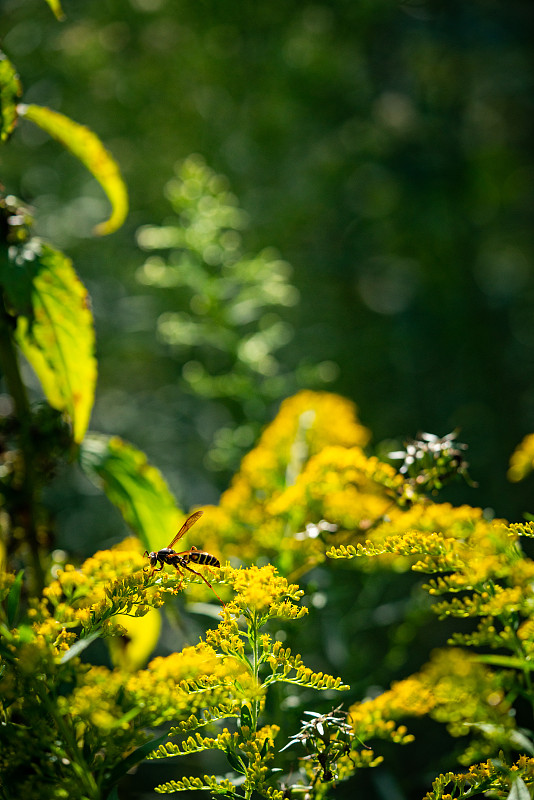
[0,239,96,443]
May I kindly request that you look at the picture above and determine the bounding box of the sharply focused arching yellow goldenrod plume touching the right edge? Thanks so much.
[327,494,534,660]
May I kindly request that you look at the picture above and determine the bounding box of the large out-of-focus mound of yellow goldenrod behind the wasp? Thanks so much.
[194,391,414,574]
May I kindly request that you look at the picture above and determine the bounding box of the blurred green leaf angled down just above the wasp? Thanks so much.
[80,433,181,550]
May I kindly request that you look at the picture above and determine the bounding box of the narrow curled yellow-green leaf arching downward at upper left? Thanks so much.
[17,103,128,236]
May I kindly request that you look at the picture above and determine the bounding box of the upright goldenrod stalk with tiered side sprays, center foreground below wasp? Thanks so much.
[149,565,348,800]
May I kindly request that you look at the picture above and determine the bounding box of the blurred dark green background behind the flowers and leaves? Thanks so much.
[0,0,534,553]
